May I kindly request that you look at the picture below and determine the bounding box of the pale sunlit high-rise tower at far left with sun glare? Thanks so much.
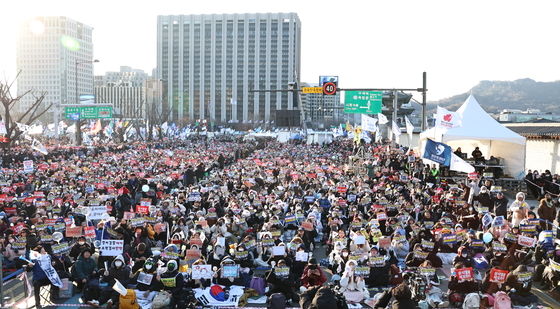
[15,16,93,113]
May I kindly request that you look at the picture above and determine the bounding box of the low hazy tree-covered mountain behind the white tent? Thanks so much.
[428,78,560,113]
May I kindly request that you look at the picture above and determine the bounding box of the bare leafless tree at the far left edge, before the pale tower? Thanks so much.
[0,71,53,149]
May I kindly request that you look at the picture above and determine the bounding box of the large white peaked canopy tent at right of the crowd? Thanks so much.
[419,95,526,178]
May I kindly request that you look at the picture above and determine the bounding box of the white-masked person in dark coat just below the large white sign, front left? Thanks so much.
[99,255,130,308]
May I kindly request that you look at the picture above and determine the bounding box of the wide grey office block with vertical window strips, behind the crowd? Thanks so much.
[157,13,301,124]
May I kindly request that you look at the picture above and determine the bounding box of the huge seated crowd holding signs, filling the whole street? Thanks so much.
[0,136,560,309]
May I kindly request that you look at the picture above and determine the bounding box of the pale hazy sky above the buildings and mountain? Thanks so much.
[0,0,560,100]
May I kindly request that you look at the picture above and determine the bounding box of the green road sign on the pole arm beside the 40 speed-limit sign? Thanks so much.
[344,91,383,114]
